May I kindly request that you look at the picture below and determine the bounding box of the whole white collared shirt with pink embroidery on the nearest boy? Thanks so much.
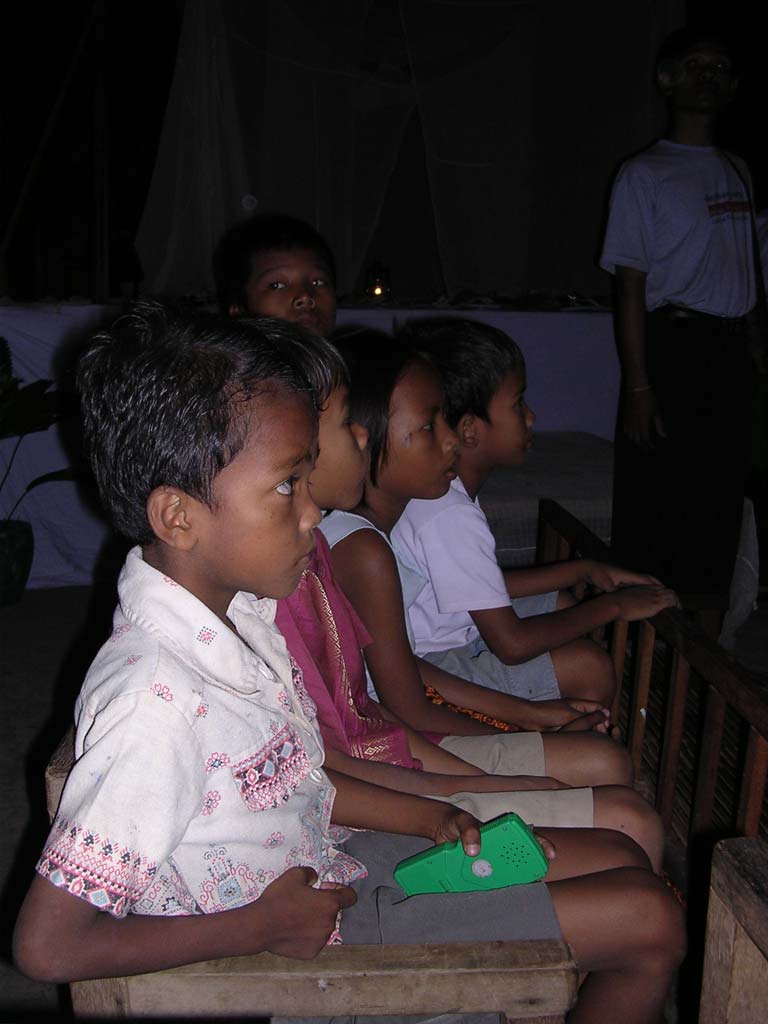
[38,548,365,918]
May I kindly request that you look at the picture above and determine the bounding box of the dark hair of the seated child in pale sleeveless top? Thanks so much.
[331,327,423,485]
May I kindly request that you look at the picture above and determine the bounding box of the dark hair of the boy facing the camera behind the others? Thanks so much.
[213,213,336,315]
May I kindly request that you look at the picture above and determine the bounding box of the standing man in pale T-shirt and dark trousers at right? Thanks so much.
[600,30,758,607]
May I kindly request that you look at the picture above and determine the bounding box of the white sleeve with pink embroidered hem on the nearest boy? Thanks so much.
[37,691,205,918]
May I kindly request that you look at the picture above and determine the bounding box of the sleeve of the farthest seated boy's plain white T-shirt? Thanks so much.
[419,503,511,614]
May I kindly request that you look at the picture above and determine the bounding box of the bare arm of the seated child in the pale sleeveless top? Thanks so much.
[332,529,495,735]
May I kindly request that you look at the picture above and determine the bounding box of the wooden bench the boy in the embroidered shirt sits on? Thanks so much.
[45,730,578,1024]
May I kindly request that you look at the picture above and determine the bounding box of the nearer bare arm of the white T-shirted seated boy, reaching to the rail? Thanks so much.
[469,586,677,665]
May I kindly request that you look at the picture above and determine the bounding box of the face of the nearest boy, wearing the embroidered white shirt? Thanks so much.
[162,392,321,620]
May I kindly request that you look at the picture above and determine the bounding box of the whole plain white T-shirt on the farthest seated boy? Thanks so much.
[392,478,512,654]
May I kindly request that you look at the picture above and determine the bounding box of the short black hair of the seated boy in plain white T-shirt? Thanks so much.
[397,316,525,427]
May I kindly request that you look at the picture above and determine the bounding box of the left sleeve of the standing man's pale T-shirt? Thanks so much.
[600,163,655,273]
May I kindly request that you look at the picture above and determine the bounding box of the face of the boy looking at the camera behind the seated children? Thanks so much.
[229,249,336,338]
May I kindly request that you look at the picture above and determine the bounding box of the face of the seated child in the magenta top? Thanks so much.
[309,387,369,509]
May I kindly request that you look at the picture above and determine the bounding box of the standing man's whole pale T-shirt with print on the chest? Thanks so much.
[600,139,755,316]
